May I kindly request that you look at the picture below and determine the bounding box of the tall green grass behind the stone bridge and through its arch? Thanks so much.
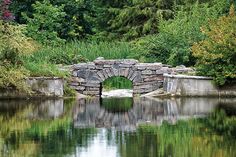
[22,41,136,89]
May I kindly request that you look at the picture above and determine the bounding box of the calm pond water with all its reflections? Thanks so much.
[0,98,236,157]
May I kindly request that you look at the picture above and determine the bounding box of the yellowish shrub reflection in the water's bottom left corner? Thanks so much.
[0,107,37,157]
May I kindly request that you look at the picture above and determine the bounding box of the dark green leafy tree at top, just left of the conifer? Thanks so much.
[50,0,94,40]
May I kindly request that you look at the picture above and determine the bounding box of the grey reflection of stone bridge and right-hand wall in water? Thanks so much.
[73,98,235,131]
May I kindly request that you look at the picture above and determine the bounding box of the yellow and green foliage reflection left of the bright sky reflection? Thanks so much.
[0,100,96,157]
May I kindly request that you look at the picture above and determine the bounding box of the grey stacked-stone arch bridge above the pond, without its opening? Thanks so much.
[69,57,191,96]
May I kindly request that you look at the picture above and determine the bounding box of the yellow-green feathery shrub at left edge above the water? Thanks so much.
[0,21,37,93]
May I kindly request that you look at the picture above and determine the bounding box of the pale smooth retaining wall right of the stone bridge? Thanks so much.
[163,74,236,97]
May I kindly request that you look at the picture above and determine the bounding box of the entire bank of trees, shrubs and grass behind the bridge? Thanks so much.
[0,0,235,92]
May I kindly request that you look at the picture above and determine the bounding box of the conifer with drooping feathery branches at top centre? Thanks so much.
[93,0,174,40]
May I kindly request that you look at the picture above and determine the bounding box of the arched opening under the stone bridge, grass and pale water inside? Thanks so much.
[100,76,133,97]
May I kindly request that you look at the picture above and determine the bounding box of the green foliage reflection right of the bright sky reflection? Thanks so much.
[117,120,236,157]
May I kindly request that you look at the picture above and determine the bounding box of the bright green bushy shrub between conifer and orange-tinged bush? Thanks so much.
[134,1,232,66]
